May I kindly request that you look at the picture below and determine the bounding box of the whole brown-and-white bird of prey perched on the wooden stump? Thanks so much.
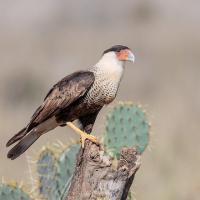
[6,45,135,160]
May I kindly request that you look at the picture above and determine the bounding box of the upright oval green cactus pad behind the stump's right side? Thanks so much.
[104,103,150,156]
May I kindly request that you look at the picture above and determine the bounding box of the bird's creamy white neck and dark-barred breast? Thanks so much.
[86,52,124,105]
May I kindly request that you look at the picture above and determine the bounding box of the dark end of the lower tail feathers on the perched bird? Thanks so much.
[7,130,40,160]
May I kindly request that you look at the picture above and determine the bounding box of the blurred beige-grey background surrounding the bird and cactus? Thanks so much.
[0,0,200,200]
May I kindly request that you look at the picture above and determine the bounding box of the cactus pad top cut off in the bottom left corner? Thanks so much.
[0,184,31,200]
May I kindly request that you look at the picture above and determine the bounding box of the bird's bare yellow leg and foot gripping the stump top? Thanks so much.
[67,122,99,148]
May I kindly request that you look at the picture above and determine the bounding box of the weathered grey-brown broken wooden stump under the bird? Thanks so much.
[65,141,140,200]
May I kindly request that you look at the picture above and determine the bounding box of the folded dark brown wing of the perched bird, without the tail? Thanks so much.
[28,71,95,130]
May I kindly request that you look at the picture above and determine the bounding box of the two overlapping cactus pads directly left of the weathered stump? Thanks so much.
[37,144,80,200]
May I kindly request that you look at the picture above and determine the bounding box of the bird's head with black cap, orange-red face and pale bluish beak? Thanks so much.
[103,45,135,62]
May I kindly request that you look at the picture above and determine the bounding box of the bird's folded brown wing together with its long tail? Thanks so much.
[7,71,95,160]
